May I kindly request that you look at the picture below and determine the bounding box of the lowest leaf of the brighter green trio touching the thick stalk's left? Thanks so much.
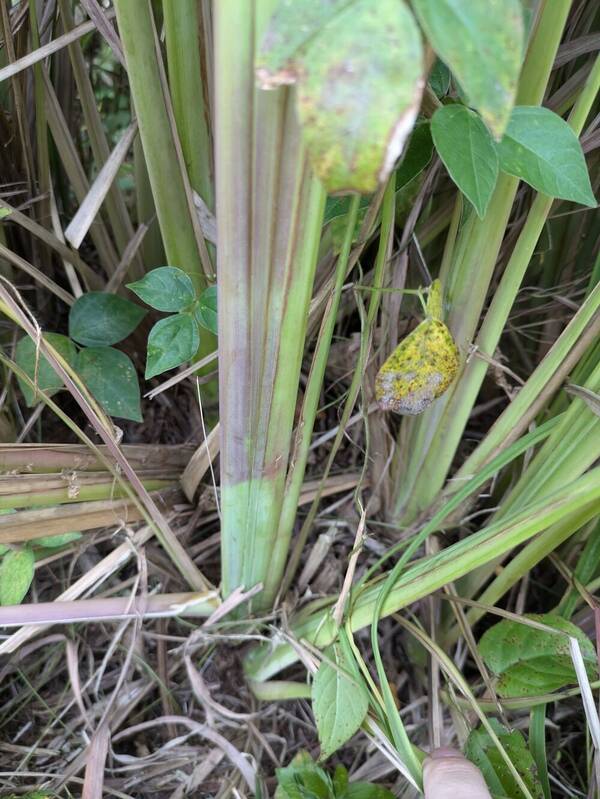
[146,314,200,380]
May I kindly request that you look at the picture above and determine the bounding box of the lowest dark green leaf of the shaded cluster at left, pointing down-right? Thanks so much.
[77,347,142,422]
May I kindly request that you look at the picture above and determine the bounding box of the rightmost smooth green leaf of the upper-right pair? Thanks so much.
[498,106,596,208]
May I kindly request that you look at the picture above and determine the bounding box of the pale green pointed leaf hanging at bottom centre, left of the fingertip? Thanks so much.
[311,643,369,760]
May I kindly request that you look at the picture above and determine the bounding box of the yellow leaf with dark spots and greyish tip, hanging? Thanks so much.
[375,281,459,415]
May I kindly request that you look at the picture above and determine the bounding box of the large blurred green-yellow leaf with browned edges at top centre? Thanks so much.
[296,0,424,193]
